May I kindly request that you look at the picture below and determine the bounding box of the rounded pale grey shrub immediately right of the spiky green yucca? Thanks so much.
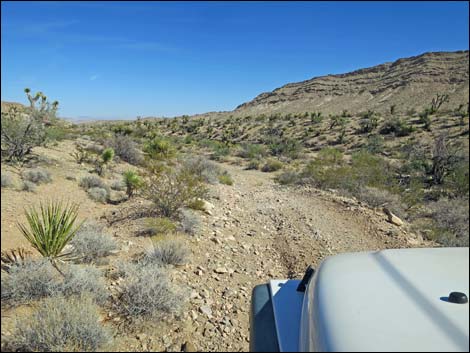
[70,223,118,263]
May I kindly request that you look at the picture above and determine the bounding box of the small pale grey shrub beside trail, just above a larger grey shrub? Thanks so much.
[141,239,189,266]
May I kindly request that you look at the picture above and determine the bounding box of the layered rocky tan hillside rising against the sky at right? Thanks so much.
[235,50,469,115]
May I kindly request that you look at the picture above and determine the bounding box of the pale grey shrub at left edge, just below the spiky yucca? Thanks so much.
[1,258,60,306]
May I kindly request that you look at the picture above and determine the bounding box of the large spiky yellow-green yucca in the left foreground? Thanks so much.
[18,201,83,265]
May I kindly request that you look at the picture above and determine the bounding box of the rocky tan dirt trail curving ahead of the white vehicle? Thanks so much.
[174,164,424,351]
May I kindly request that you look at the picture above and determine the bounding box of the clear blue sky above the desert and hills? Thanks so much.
[1,1,469,118]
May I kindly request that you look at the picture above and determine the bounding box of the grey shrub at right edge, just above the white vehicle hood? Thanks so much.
[429,198,469,246]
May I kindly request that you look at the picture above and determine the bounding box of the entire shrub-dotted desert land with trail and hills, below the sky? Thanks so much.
[1,52,469,351]
